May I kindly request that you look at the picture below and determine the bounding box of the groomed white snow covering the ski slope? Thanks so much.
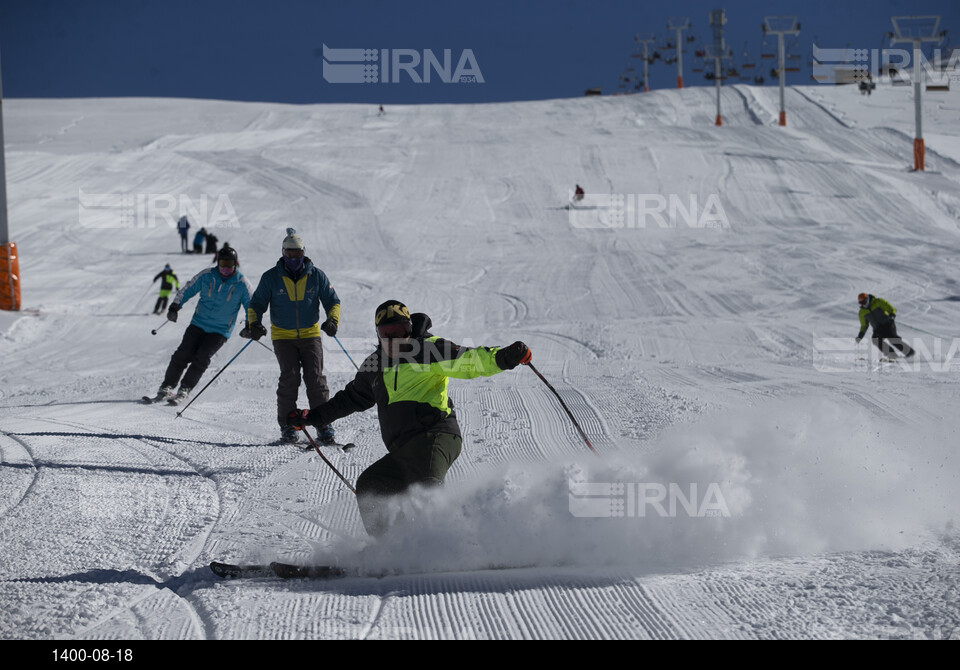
[0,85,960,641]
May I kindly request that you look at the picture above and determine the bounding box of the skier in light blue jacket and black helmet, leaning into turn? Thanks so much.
[144,245,251,402]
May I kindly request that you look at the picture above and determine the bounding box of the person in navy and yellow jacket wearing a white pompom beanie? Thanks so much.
[240,228,340,443]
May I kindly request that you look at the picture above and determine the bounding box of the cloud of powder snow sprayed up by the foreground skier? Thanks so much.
[318,399,960,571]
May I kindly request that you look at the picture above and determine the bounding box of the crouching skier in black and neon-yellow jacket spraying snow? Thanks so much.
[288,300,531,537]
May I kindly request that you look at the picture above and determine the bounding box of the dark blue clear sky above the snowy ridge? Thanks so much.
[0,0,960,104]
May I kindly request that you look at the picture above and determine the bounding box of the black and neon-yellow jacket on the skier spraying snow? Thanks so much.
[310,315,510,451]
